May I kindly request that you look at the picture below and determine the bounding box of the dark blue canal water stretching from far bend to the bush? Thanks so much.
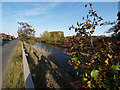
[35,43,76,78]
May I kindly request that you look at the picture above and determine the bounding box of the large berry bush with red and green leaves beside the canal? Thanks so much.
[68,3,120,89]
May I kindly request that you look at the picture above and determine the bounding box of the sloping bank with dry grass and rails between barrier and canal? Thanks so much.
[24,43,75,88]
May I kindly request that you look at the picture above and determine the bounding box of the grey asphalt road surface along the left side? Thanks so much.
[0,40,18,77]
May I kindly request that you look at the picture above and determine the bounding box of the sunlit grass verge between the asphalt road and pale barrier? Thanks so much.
[2,42,25,88]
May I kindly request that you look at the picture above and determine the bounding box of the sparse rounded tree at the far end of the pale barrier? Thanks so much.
[17,22,35,42]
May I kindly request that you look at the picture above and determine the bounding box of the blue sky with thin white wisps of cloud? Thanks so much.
[2,2,118,37]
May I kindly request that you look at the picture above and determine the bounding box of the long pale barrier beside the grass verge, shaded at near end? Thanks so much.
[21,43,35,90]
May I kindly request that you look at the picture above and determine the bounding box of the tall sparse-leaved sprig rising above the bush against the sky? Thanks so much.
[69,3,103,53]
